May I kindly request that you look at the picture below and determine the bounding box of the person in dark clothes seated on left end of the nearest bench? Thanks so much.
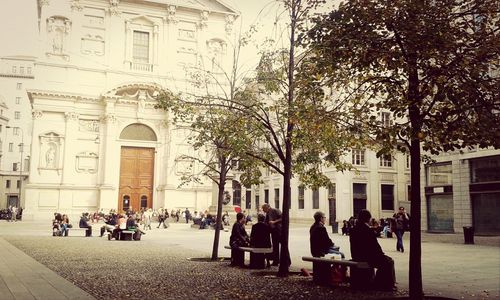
[309,211,345,259]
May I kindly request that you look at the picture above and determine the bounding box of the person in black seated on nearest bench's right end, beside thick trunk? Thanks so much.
[349,209,396,291]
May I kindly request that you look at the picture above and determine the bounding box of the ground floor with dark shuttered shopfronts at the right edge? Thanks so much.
[422,149,500,235]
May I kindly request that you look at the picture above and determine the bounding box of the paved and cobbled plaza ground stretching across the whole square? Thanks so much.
[0,221,500,299]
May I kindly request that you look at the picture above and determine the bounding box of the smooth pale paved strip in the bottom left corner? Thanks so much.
[0,237,94,300]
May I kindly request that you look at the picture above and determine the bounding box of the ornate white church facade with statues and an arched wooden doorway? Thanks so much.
[24,0,238,218]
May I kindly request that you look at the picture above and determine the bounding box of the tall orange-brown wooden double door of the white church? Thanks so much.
[118,147,155,211]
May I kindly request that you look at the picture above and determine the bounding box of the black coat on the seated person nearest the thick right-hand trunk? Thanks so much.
[349,222,384,265]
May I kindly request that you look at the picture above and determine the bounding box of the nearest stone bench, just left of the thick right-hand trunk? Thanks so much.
[302,256,374,290]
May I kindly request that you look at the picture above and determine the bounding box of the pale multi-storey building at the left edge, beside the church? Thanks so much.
[0,56,35,208]
